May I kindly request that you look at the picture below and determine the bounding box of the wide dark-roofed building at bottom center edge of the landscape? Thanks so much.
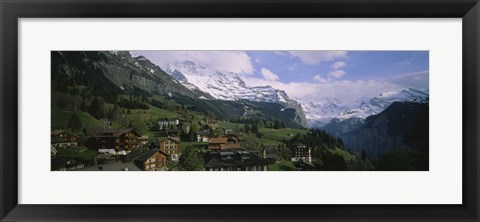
[204,148,268,171]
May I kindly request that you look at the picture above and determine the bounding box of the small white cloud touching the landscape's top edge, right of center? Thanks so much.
[288,51,347,65]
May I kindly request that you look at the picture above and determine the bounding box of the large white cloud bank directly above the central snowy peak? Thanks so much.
[132,50,255,74]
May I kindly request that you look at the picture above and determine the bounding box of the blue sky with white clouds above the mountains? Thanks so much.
[132,51,429,101]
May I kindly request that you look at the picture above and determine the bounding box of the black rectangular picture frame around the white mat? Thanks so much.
[0,0,480,221]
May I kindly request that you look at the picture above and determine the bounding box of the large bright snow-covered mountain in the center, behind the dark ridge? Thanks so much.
[165,60,307,127]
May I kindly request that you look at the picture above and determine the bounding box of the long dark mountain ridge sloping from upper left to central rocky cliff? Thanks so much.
[51,51,304,128]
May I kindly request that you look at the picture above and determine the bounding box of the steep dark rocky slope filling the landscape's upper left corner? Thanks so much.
[52,51,211,98]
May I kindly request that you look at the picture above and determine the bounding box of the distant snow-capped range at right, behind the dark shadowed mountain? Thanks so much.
[297,88,429,127]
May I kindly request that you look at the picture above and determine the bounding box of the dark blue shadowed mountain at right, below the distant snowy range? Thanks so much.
[324,102,429,156]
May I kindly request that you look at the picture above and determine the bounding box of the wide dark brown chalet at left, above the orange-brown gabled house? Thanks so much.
[85,129,141,155]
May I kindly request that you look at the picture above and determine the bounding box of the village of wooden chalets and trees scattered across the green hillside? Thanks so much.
[51,118,314,171]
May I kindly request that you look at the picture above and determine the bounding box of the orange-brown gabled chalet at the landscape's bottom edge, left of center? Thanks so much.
[134,149,168,171]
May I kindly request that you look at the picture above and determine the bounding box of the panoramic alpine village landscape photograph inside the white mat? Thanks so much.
[50,50,429,171]
